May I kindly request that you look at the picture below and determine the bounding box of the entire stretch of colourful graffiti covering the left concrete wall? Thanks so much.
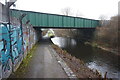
[0,20,37,78]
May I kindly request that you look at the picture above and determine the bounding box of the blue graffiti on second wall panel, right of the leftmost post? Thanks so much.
[11,26,23,62]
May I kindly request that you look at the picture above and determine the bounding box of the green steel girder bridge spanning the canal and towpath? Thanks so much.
[11,9,99,28]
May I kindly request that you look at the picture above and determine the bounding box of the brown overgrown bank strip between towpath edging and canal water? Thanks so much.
[51,45,102,79]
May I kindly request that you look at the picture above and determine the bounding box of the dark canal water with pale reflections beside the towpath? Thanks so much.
[51,37,120,79]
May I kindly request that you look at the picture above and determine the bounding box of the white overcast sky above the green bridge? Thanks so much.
[0,0,120,19]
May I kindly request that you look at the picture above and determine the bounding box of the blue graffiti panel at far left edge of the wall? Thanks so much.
[0,25,12,77]
